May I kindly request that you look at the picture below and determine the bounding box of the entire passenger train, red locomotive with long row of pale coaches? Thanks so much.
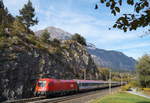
[35,78,124,96]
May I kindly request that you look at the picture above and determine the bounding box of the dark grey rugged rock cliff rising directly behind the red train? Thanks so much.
[0,40,97,101]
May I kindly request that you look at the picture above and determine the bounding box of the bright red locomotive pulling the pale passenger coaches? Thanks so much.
[35,78,78,95]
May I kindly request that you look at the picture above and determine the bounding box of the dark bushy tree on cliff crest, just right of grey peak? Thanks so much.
[72,33,87,46]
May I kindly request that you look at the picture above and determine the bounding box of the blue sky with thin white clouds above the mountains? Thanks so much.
[3,0,150,59]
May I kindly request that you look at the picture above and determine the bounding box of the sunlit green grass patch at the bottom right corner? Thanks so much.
[92,92,150,103]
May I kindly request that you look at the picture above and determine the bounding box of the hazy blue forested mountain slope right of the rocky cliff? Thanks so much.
[87,44,136,71]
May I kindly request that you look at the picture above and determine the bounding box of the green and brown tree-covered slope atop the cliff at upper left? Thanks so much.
[0,0,60,53]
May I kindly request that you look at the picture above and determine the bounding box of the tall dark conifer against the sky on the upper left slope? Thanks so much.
[18,0,38,30]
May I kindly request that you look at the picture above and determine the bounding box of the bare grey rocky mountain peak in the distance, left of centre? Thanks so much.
[35,26,72,40]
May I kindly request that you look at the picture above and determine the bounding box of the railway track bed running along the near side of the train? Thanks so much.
[3,87,117,103]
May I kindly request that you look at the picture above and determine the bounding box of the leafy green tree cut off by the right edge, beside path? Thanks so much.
[136,55,150,87]
